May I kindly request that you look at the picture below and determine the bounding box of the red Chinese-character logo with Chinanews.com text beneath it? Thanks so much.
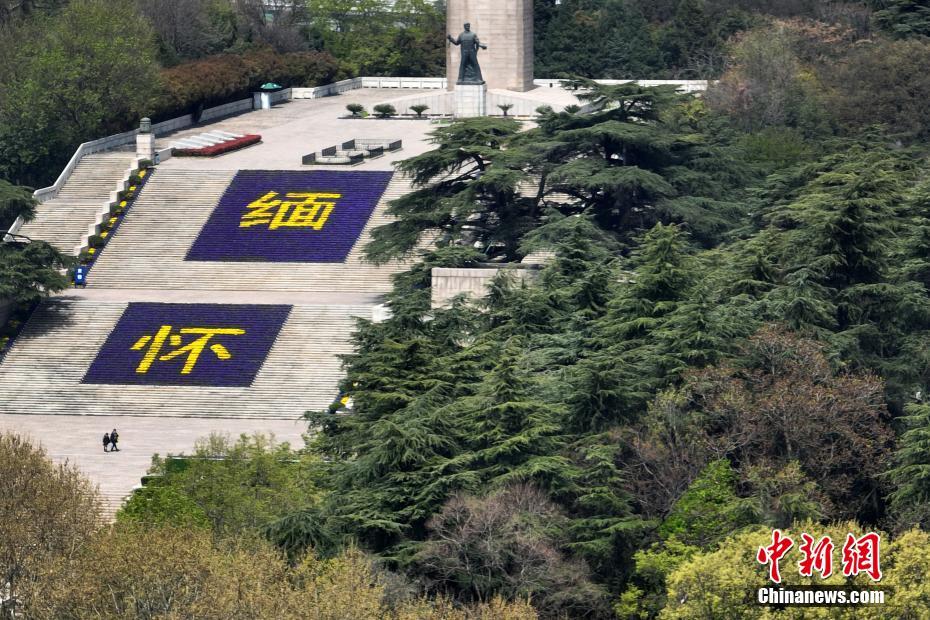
[756,530,886,607]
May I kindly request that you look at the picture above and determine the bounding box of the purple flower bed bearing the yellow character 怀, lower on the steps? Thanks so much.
[81,302,291,387]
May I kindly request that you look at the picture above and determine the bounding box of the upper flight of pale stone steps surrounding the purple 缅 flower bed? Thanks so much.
[88,169,410,294]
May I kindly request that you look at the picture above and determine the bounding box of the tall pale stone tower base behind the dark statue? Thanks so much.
[446,0,534,92]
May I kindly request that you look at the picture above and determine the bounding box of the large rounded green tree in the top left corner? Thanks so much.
[0,0,157,186]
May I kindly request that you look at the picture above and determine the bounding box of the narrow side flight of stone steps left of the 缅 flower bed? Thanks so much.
[19,152,135,255]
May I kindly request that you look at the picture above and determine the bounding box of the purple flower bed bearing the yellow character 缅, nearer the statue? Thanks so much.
[186,170,393,263]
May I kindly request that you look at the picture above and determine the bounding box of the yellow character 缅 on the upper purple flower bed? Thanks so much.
[239,192,342,230]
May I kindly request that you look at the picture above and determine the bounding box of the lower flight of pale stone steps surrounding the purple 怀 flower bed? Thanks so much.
[0,298,371,418]
